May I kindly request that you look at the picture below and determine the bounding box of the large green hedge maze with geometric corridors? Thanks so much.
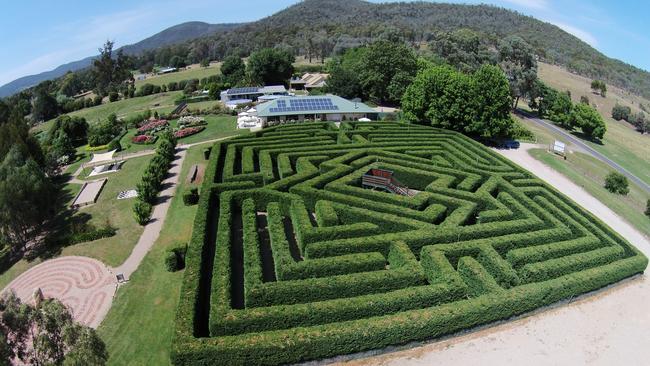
[172,122,647,365]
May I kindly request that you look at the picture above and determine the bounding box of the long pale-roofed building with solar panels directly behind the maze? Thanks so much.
[257,95,377,126]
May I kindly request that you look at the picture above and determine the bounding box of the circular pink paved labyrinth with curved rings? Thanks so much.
[3,256,117,328]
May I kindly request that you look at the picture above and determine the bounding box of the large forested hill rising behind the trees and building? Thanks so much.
[190,0,650,97]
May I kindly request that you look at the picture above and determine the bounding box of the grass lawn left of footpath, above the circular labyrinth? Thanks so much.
[0,156,152,287]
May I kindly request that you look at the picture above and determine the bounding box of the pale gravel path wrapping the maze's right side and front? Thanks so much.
[328,144,650,366]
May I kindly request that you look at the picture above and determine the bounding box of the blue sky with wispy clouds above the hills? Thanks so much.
[0,0,650,85]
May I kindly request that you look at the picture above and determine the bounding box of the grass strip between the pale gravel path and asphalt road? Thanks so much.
[530,149,650,237]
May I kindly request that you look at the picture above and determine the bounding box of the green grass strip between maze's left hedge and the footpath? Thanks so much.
[99,146,207,365]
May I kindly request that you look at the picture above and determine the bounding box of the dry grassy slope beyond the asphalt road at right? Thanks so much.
[538,63,650,184]
